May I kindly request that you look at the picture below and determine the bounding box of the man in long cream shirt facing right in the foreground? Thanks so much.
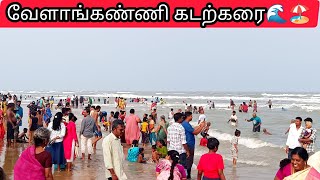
[102,120,128,180]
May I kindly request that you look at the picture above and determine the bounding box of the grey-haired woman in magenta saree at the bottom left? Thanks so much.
[13,128,53,180]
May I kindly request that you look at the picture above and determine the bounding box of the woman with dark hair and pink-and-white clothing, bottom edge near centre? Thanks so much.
[156,150,187,180]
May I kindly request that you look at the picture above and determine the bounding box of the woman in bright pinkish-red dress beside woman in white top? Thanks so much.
[63,113,79,171]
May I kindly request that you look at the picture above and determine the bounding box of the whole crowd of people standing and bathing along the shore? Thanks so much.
[0,95,320,180]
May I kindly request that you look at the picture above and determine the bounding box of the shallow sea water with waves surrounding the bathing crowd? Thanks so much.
[0,92,320,180]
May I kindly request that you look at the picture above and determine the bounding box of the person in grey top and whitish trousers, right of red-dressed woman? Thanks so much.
[80,108,96,160]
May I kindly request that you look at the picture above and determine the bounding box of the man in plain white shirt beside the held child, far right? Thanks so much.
[286,117,303,159]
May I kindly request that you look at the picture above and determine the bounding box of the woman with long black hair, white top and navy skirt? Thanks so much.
[48,112,66,171]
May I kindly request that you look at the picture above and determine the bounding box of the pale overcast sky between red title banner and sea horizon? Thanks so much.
[0,22,320,92]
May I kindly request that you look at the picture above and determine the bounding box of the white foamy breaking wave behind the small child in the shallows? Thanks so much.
[208,129,282,149]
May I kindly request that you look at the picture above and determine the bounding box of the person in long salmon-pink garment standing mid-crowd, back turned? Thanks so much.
[125,109,141,145]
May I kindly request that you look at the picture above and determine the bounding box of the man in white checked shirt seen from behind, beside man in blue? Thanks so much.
[167,113,190,168]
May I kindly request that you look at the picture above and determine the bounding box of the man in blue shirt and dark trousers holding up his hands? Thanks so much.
[181,112,205,179]
